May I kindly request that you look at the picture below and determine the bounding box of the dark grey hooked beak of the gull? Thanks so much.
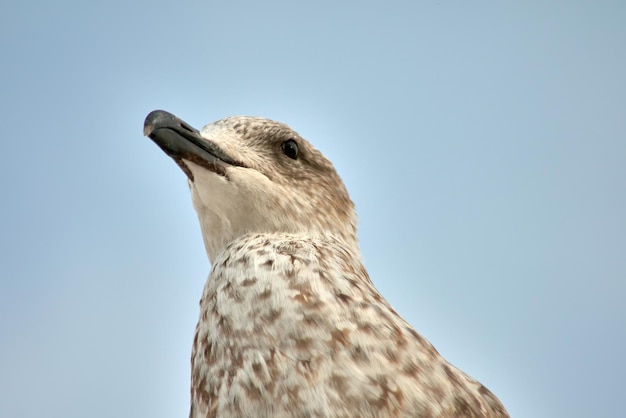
[143,110,243,181]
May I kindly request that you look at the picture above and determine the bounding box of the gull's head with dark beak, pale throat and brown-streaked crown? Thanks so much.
[144,110,357,262]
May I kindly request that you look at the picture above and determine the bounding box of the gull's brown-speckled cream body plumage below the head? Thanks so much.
[192,234,507,417]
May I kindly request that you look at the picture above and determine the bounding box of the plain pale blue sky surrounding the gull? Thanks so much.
[0,0,626,418]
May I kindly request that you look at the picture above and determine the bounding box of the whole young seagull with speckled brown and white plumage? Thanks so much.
[144,110,509,418]
